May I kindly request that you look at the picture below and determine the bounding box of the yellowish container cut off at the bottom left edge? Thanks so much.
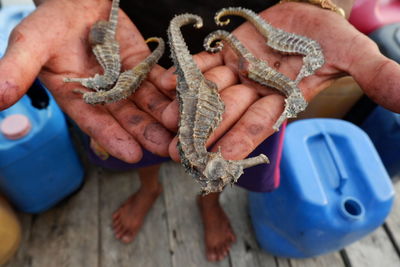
[0,196,21,265]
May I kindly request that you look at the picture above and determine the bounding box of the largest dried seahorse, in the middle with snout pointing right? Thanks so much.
[168,14,269,194]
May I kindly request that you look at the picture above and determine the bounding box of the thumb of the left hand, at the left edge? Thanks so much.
[0,27,47,110]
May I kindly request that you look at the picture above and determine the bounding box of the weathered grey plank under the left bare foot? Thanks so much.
[100,170,171,267]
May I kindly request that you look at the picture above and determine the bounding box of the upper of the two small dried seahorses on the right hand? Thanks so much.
[214,7,325,84]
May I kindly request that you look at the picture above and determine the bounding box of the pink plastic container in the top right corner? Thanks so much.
[349,0,400,34]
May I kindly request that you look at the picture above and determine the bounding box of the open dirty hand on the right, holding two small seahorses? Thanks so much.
[160,3,400,160]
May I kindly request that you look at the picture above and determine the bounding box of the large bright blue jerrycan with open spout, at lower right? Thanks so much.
[249,119,394,258]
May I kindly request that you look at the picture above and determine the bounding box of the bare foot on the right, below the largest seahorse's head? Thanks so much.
[197,193,236,261]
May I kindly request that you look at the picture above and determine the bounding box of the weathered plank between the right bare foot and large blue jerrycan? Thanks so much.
[221,186,276,267]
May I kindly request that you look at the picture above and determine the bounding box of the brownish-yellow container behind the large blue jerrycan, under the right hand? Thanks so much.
[297,77,363,119]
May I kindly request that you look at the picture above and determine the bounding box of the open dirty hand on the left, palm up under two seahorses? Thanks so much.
[0,0,172,162]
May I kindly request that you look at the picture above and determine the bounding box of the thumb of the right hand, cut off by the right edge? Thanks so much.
[347,37,400,113]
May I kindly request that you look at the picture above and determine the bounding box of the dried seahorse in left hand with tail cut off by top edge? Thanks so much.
[64,0,121,91]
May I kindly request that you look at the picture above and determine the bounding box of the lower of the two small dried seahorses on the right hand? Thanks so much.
[204,30,307,131]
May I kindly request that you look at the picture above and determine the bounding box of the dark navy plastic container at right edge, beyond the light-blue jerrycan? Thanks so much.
[361,107,400,176]
